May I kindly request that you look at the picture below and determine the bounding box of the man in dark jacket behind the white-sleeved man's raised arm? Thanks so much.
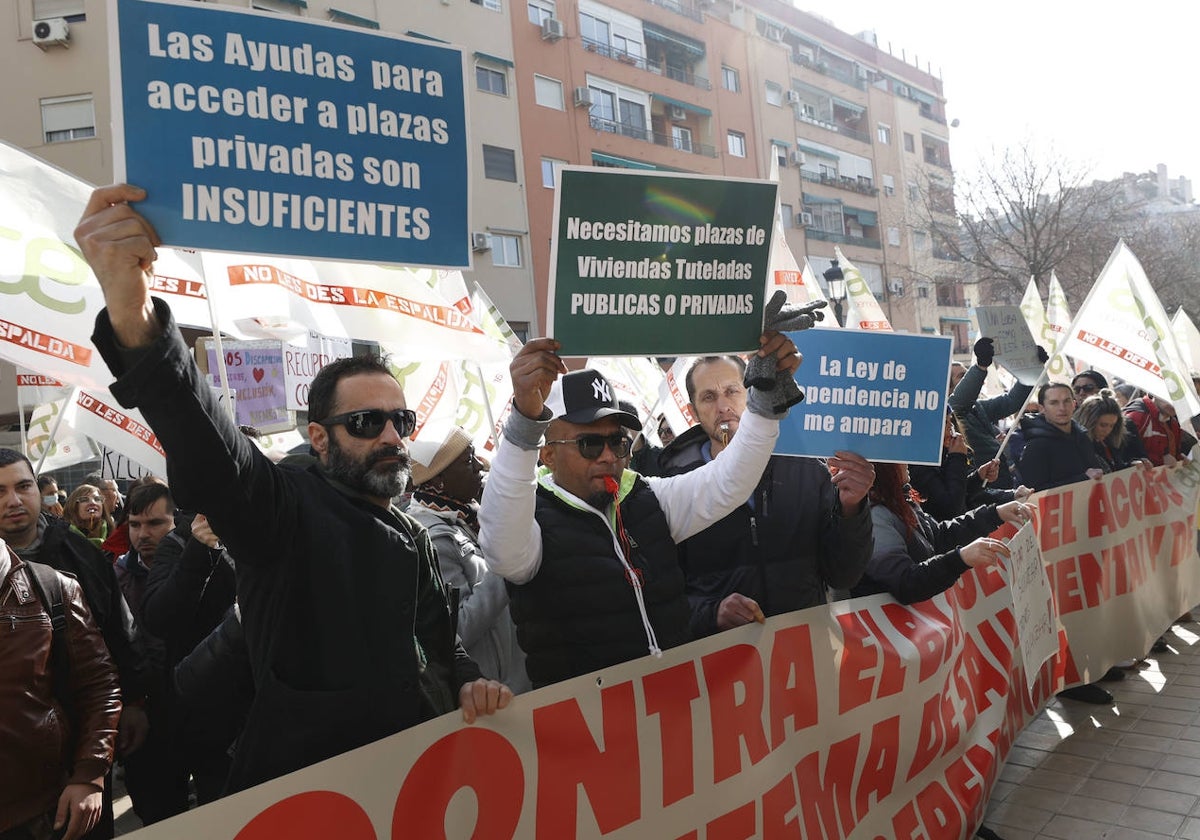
[660,356,875,637]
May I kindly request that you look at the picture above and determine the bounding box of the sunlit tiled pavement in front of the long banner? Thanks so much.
[114,613,1200,840]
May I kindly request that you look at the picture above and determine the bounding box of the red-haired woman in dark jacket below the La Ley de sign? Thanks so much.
[852,463,1030,604]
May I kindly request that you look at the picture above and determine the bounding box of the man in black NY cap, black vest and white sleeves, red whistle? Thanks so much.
[479,330,800,688]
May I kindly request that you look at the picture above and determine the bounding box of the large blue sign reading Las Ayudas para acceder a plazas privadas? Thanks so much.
[110,0,470,268]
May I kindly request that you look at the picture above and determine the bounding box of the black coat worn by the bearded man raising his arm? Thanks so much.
[92,300,479,790]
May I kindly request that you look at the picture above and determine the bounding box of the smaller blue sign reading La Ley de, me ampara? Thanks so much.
[775,330,950,464]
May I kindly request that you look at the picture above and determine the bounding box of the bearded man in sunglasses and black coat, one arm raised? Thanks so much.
[76,185,511,791]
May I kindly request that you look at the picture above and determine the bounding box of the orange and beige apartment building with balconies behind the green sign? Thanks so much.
[512,0,967,340]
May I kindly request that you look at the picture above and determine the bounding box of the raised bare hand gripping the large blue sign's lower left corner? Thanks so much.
[74,184,162,348]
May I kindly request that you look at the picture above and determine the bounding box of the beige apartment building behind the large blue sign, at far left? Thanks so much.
[0,0,536,332]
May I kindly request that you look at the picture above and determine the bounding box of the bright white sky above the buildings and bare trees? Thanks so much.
[793,0,1200,197]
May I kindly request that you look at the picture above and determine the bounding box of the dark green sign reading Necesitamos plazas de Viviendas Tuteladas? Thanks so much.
[546,167,776,356]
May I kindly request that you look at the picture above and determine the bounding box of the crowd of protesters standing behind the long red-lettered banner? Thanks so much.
[0,186,1195,840]
